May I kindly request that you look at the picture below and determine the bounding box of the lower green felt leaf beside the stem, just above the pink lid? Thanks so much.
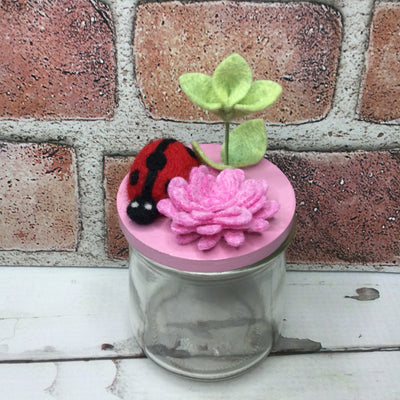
[221,119,267,167]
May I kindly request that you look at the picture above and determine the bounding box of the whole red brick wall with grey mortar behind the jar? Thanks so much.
[0,0,400,270]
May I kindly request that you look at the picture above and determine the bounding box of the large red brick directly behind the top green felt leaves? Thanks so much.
[134,1,342,123]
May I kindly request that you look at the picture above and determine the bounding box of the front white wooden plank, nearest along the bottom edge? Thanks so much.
[0,351,400,400]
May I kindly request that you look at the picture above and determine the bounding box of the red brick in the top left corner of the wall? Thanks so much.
[0,0,116,119]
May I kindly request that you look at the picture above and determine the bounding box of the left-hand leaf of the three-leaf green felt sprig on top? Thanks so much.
[179,73,222,111]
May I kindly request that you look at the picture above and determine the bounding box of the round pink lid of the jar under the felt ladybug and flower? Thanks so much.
[117,144,296,272]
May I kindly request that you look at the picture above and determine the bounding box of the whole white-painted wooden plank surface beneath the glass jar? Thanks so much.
[0,267,400,400]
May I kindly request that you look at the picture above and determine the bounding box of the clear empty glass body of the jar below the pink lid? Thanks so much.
[129,246,286,380]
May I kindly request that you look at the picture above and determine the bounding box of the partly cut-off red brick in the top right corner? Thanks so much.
[358,3,400,122]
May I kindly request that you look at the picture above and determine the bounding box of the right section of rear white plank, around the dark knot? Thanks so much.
[283,272,400,350]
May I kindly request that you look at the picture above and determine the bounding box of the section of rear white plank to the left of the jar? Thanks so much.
[0,268,142,360]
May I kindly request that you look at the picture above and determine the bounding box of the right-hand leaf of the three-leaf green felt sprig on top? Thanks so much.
[234,81,282,113]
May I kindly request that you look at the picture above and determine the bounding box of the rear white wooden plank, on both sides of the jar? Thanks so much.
[0,267,400,361]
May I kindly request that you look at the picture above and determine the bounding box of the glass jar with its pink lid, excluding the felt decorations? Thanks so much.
[117,144,296,380]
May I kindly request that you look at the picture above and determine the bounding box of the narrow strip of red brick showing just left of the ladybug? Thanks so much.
[104,157,133,258]
